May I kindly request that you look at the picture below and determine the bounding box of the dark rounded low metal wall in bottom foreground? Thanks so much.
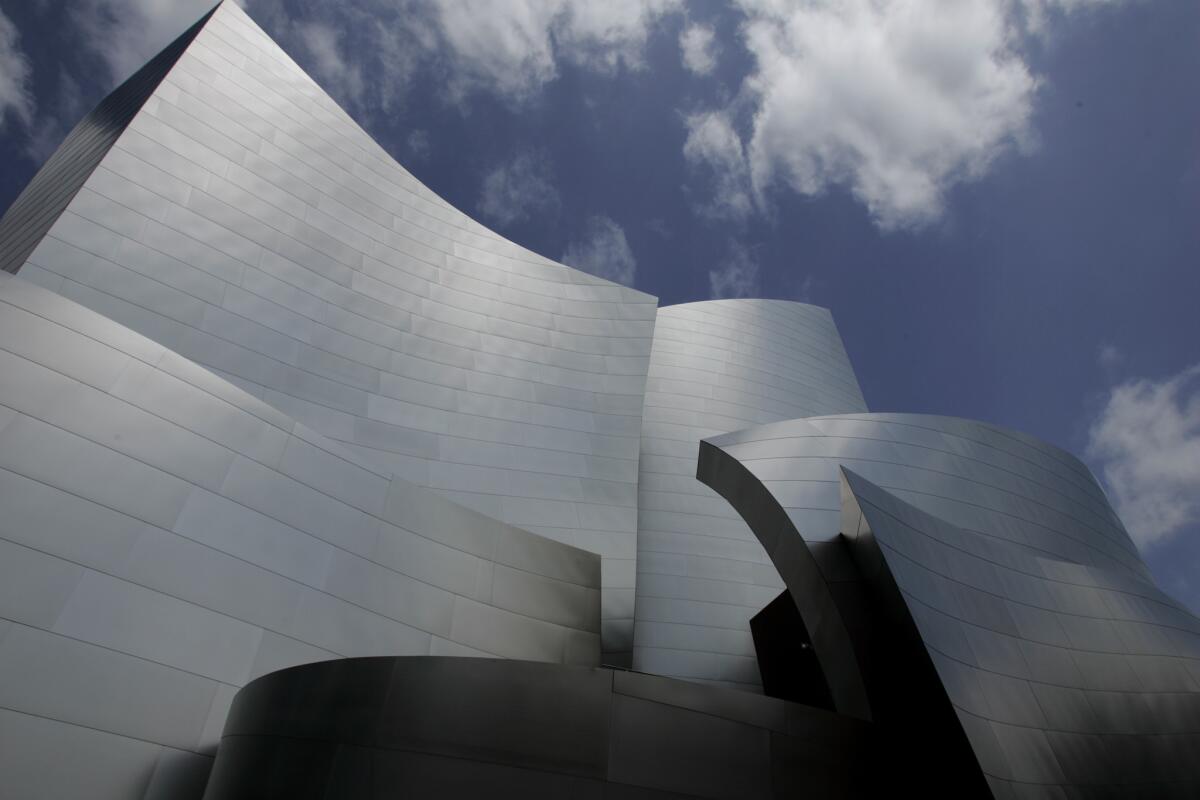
[205,657,872,800]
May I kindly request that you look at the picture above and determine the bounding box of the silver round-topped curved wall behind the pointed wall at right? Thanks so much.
[709,414,1148,577]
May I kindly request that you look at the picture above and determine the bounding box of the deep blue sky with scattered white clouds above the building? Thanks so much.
[0,0,1200,609]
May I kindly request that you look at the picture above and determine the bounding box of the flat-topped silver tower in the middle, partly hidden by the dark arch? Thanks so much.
[634,300,865,690]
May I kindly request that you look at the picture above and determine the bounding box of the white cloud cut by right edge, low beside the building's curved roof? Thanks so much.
[1087,365,1200,547]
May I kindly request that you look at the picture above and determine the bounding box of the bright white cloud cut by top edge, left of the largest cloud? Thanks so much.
[434,0,680,101]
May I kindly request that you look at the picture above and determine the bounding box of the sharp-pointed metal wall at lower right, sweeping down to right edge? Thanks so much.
[845,473,1200,800]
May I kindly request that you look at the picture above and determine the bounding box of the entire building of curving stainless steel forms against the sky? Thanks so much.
[0,2,1200,799]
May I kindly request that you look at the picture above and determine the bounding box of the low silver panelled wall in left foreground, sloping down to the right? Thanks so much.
[0,275,600,798]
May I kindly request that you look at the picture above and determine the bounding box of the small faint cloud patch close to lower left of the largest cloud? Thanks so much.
[683,112,754,219]
